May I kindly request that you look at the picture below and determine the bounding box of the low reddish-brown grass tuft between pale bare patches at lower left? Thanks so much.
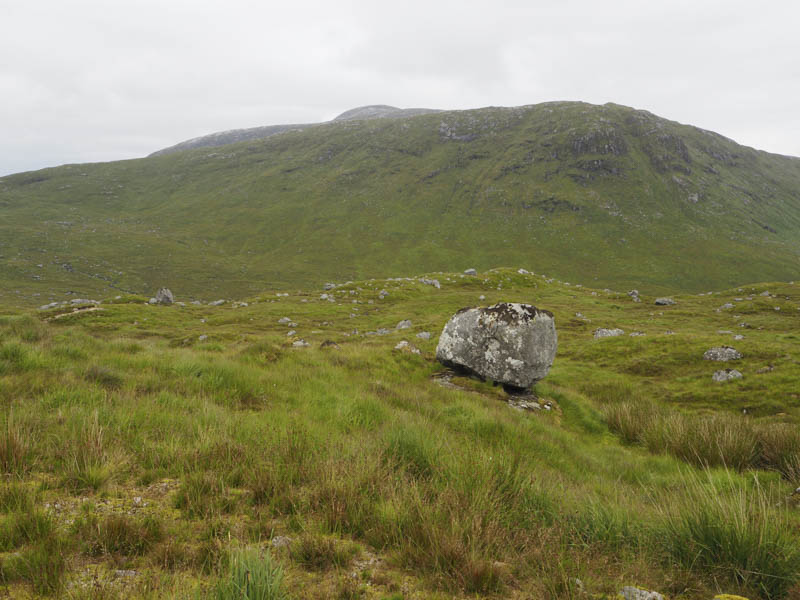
[72,514,164,556]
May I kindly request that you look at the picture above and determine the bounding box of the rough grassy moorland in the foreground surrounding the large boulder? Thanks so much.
[0,270,800,600]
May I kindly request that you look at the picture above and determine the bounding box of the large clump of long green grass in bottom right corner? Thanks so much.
[658,474,800,598]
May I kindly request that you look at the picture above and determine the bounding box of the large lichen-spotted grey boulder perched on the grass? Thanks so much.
[436,302,558,389]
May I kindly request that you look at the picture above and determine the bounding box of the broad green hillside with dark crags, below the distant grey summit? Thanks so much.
[0,102,800,304]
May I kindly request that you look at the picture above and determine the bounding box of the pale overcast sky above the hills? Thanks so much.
[0,0,800,175]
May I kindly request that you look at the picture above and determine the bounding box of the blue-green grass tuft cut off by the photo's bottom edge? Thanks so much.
[212,547,289,600]
